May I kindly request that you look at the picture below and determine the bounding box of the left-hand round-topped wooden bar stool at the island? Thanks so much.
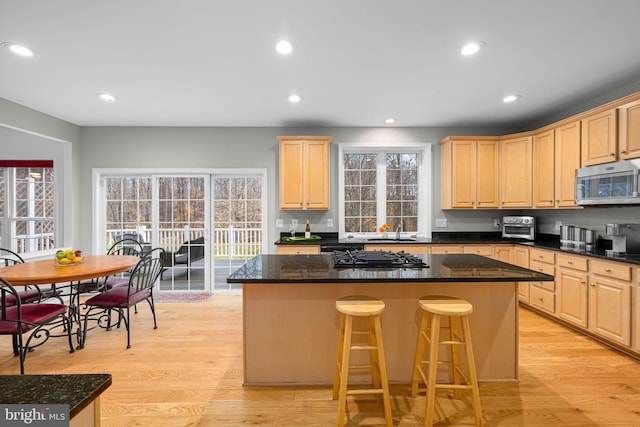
[333,295,393,427]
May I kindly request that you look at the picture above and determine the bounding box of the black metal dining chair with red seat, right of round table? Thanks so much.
[82,251,162,348]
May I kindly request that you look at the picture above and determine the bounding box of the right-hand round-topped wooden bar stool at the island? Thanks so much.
[411,296,482,426]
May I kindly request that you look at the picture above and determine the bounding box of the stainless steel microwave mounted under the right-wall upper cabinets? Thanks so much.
[576,159,640,205]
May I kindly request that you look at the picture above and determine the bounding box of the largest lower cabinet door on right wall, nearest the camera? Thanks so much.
[589,276,631,346]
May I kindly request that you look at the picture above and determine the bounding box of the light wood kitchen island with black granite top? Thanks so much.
[227,254,553,385]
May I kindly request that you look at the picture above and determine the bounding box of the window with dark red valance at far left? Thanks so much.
[0,160,56,254]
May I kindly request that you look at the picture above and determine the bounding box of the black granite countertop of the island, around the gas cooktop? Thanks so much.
[227,254,554,283]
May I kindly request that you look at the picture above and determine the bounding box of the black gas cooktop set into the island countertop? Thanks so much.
[333,250,429,268]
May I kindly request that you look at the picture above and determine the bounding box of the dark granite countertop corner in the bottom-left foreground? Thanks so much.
[0,374,111,418]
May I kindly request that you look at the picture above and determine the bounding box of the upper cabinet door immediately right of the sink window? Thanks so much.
[448,141,476,209]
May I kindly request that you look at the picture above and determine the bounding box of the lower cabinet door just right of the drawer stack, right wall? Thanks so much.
[556,268,589,328]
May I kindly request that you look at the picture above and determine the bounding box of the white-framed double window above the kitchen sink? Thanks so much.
[339,144,431,235]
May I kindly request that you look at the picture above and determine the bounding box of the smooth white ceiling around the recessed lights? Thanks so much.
[0,0,640,127]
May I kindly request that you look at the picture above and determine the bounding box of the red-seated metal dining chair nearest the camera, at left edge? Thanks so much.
[0,277,74,375]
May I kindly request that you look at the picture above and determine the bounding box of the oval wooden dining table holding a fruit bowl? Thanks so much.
[0,255,140,349]
